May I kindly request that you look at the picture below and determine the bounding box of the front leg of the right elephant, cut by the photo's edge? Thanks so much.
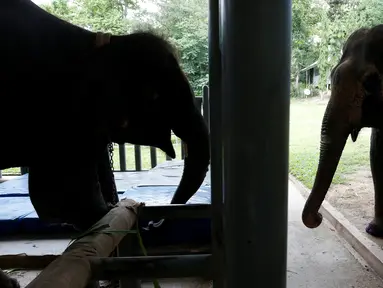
[366,129,383,238]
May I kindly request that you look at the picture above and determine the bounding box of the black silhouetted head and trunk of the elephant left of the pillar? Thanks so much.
[92,32,210,204]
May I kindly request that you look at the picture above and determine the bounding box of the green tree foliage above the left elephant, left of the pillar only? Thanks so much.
[41,0,208,95]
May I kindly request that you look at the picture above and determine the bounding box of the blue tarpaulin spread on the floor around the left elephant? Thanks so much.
[0,174,211,245]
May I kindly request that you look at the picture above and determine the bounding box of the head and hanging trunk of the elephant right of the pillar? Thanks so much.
[302,25,383,228]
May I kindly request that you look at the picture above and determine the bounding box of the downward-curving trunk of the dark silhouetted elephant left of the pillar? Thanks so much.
[171,107,210,204]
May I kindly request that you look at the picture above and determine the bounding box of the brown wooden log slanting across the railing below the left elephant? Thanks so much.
[26,199,141,288]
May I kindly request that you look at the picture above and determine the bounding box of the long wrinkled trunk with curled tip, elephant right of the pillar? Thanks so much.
[302,100,350,228]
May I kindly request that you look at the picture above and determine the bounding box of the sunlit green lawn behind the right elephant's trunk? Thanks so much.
[290,100,370,189]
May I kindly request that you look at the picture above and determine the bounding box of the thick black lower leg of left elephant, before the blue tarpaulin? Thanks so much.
[29,158,109,230]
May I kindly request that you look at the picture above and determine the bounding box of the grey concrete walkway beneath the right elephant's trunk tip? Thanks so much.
[287,182,383,288]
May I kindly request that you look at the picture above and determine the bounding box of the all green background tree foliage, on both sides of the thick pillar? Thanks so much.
[37,0,383,96]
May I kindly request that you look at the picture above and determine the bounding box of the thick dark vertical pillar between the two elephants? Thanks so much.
[222,0,291,288]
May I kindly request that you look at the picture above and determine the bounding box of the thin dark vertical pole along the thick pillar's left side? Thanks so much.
[208,0,224,288]
